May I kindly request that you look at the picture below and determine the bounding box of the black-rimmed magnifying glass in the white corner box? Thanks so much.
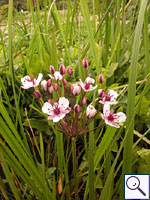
[126,176,146,196]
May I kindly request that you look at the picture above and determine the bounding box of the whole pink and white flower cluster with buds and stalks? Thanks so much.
[21,59,126,137]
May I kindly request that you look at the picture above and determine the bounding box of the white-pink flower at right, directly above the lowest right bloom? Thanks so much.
[99,90,118,105]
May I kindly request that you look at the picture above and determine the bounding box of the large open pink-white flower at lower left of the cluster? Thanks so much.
[42,97,71,122]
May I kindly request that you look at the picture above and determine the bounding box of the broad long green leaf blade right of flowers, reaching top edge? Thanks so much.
[122,0,147,197]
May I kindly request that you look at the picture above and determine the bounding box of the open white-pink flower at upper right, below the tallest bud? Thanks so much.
[80,77,97,92]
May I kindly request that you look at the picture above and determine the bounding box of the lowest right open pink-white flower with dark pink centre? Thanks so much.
[101,104,126,128]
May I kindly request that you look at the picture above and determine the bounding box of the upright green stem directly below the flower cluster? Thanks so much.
[72,137,79,200]
